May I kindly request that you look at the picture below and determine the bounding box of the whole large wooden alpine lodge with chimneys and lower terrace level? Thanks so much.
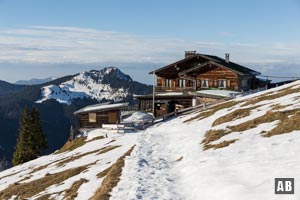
[135,51,266,116]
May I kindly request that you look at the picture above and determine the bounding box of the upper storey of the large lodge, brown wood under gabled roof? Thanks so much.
[155,51,259,92]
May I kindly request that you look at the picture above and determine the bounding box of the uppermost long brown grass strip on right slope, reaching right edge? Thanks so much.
[244,86,300,106]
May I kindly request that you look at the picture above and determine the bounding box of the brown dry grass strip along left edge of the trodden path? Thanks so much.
[90,146,134,200]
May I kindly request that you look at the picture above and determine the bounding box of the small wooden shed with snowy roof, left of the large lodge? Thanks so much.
[74,103,128,128]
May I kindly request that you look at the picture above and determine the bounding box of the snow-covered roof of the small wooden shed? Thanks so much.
[74,103,129,115]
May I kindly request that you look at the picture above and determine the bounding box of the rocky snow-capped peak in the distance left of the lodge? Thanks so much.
[36,67,142,105]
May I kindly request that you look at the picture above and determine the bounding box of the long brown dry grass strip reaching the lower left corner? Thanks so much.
[0,165,89,199]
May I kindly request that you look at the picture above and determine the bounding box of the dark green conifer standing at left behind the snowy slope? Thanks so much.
[12,107,47,166]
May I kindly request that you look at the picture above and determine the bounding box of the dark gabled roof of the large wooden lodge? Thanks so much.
[150,53,260,75]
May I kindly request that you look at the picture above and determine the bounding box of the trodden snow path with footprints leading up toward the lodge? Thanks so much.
[111,124,183,200]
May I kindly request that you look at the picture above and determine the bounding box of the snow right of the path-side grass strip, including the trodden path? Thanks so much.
[111,81,300,200]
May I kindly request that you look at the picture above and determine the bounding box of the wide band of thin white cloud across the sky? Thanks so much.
[0,26,300,64]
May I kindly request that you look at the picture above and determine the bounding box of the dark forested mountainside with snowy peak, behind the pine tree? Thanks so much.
[0,67,152,166]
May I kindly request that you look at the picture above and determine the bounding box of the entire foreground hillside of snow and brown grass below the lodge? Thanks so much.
[0,81,300,200]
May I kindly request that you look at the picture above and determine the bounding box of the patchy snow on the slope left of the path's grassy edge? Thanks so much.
[0,129,136,200]
